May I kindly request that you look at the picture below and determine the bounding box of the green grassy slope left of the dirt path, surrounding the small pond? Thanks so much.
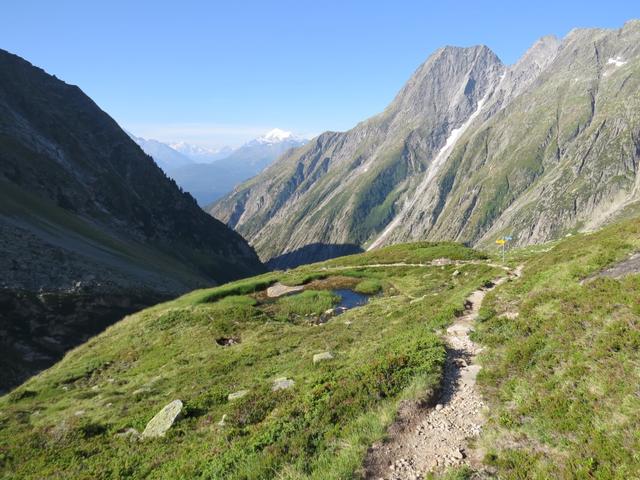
[0,244,497,479]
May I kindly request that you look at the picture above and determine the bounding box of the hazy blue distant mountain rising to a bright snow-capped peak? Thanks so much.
[168,128,306,206]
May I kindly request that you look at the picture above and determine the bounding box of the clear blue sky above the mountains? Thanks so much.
[0,0,640,145]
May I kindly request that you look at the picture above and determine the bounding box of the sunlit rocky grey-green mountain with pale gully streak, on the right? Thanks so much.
[209,20,640,266]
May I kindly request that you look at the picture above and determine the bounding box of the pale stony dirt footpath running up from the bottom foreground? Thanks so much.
[365,267,521,480]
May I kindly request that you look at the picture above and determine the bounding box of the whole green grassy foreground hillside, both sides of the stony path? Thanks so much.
[0,219,640,479]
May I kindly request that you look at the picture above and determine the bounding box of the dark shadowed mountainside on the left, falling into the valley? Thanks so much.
[0,50,263,388]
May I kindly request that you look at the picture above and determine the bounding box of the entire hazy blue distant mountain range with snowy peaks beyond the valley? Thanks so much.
[132,128,307,207]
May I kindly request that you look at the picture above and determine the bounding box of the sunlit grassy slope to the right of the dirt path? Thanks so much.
[477,218,640,479]
